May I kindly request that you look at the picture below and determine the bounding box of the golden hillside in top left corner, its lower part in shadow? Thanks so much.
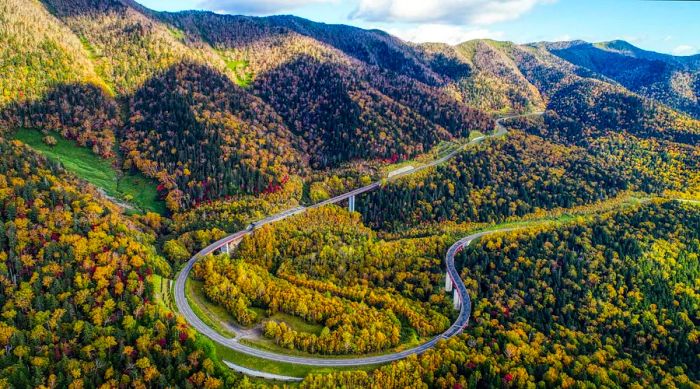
[0,0,119,157]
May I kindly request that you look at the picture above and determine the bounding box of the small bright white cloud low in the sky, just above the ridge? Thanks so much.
[387,23,503,44]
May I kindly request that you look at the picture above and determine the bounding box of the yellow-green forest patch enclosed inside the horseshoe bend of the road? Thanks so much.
[193,207,451,354]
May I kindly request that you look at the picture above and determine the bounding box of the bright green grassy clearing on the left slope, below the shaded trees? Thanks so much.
[13,129,166,214]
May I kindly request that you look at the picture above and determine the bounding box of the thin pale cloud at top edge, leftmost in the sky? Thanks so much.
[199,0,336,15]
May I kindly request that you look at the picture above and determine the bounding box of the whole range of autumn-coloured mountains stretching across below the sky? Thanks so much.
[0,0,700,208]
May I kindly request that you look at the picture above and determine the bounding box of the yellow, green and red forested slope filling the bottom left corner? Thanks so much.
[0,138,243,388]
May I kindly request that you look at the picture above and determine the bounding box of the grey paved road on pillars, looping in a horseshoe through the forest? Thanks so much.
[175,112,541,366]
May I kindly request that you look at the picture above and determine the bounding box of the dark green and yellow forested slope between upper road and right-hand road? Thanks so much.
[358,130,700,229]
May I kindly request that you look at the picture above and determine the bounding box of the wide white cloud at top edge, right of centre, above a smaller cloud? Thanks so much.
[350,0,554,25]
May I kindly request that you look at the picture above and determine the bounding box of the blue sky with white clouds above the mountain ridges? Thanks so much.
[137,0,700,55]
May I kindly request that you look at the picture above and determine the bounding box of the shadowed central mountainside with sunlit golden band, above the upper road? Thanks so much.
[164,13,490,167]
